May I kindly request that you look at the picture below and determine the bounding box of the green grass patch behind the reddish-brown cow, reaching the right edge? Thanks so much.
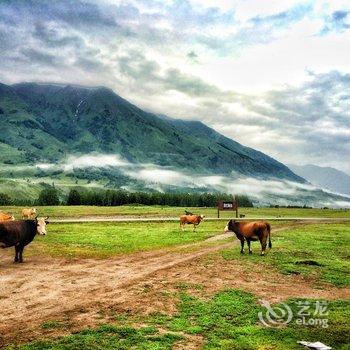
[222,223,350,286]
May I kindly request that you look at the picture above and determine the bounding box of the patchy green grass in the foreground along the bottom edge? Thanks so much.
[8,289,350,350]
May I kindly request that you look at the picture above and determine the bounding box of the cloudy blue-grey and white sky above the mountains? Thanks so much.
[0,0,350,173]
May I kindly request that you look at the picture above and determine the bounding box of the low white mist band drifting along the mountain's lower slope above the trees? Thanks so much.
[31,154,350,207]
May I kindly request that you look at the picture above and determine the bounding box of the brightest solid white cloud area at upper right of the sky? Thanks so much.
[197,31,350,94]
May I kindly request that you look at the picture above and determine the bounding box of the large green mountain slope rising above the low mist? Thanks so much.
[0,83,304,182]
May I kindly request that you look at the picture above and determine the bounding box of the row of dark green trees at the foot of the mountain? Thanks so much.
[0,186,253,207]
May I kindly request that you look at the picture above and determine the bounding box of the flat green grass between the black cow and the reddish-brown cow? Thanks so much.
[28,221,225,258]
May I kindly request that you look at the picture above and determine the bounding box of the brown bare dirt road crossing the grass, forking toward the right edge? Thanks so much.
[0,228,348,346]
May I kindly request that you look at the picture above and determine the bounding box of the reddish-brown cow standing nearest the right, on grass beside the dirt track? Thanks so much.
[225,220,272,255]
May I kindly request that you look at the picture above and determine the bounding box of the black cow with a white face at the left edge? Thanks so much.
[0,218,48,263]
